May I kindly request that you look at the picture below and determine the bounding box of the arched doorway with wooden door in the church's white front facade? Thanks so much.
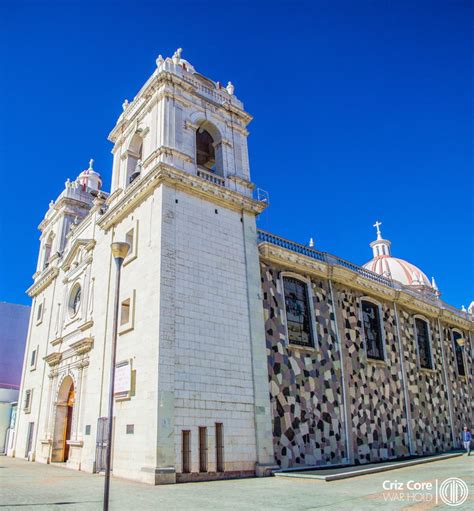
[51,376,75,462]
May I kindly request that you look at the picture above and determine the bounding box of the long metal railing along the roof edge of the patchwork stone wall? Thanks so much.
[257,229,472,320]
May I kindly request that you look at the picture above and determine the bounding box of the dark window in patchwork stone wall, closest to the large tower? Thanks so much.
[283,277,314,346]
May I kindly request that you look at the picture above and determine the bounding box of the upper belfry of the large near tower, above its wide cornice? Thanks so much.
[109,49,252,197]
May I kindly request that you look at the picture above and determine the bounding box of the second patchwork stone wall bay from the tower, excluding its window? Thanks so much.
[334,286,409,463]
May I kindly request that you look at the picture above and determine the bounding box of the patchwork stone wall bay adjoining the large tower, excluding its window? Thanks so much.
[261,263,346,468]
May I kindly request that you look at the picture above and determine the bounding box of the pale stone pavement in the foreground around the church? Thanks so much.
[0,456,474,511]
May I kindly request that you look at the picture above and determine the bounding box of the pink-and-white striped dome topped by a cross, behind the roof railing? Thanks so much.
[363,221,438,293]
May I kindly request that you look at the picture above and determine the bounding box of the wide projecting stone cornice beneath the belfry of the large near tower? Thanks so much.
[98,163,267,231]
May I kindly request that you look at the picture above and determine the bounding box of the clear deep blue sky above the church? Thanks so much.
[0,0,474,306]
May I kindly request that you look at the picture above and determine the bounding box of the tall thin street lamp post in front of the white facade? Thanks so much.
[104,242,130,511]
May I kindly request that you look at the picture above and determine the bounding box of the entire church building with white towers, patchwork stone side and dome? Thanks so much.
[10,49,474,484]
